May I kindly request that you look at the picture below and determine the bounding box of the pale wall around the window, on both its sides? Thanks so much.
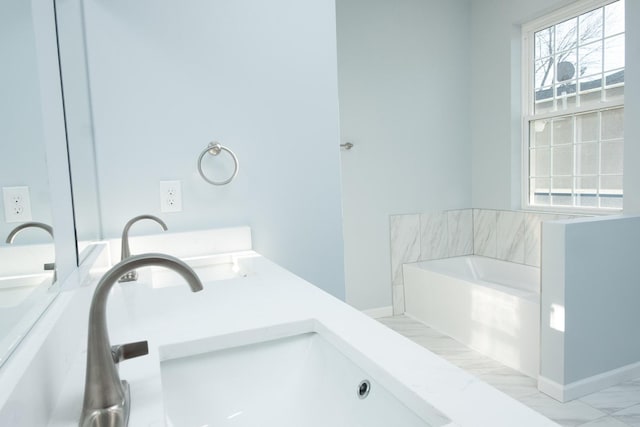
[471,0,640,213]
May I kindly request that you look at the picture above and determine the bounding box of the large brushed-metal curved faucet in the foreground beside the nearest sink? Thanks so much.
[79,254,202,427]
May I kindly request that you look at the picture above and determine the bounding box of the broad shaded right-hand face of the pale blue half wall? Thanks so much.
[564,217,640,383]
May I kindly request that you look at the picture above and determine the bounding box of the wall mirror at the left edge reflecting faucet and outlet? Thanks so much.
[0,0,57,365]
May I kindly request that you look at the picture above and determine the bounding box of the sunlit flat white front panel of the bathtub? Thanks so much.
[404,264,540,378]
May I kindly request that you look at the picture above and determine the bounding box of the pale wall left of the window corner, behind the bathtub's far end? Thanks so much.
[337,0,471,309]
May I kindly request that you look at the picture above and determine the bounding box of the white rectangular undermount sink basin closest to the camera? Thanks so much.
[160,321,449,427]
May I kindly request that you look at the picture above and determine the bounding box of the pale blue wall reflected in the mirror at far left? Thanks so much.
[0,1,52,246]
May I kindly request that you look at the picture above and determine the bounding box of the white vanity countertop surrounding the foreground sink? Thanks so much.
[49,252,557,427]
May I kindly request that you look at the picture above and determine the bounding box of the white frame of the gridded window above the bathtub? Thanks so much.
[520,0,633,215]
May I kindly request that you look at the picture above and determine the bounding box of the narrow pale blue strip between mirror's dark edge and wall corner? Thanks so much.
[54,0,102,264]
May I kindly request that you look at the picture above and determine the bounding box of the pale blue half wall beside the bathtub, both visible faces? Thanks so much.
[540,216,640,394]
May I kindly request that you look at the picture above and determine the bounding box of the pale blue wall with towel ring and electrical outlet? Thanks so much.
[85,0,344,298]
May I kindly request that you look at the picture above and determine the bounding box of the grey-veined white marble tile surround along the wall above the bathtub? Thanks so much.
[390,209,578,314]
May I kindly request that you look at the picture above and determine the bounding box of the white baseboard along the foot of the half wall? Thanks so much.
[538,362,640,402]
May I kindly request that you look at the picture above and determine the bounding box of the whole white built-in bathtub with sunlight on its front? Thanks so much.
[403,255,540,378]
